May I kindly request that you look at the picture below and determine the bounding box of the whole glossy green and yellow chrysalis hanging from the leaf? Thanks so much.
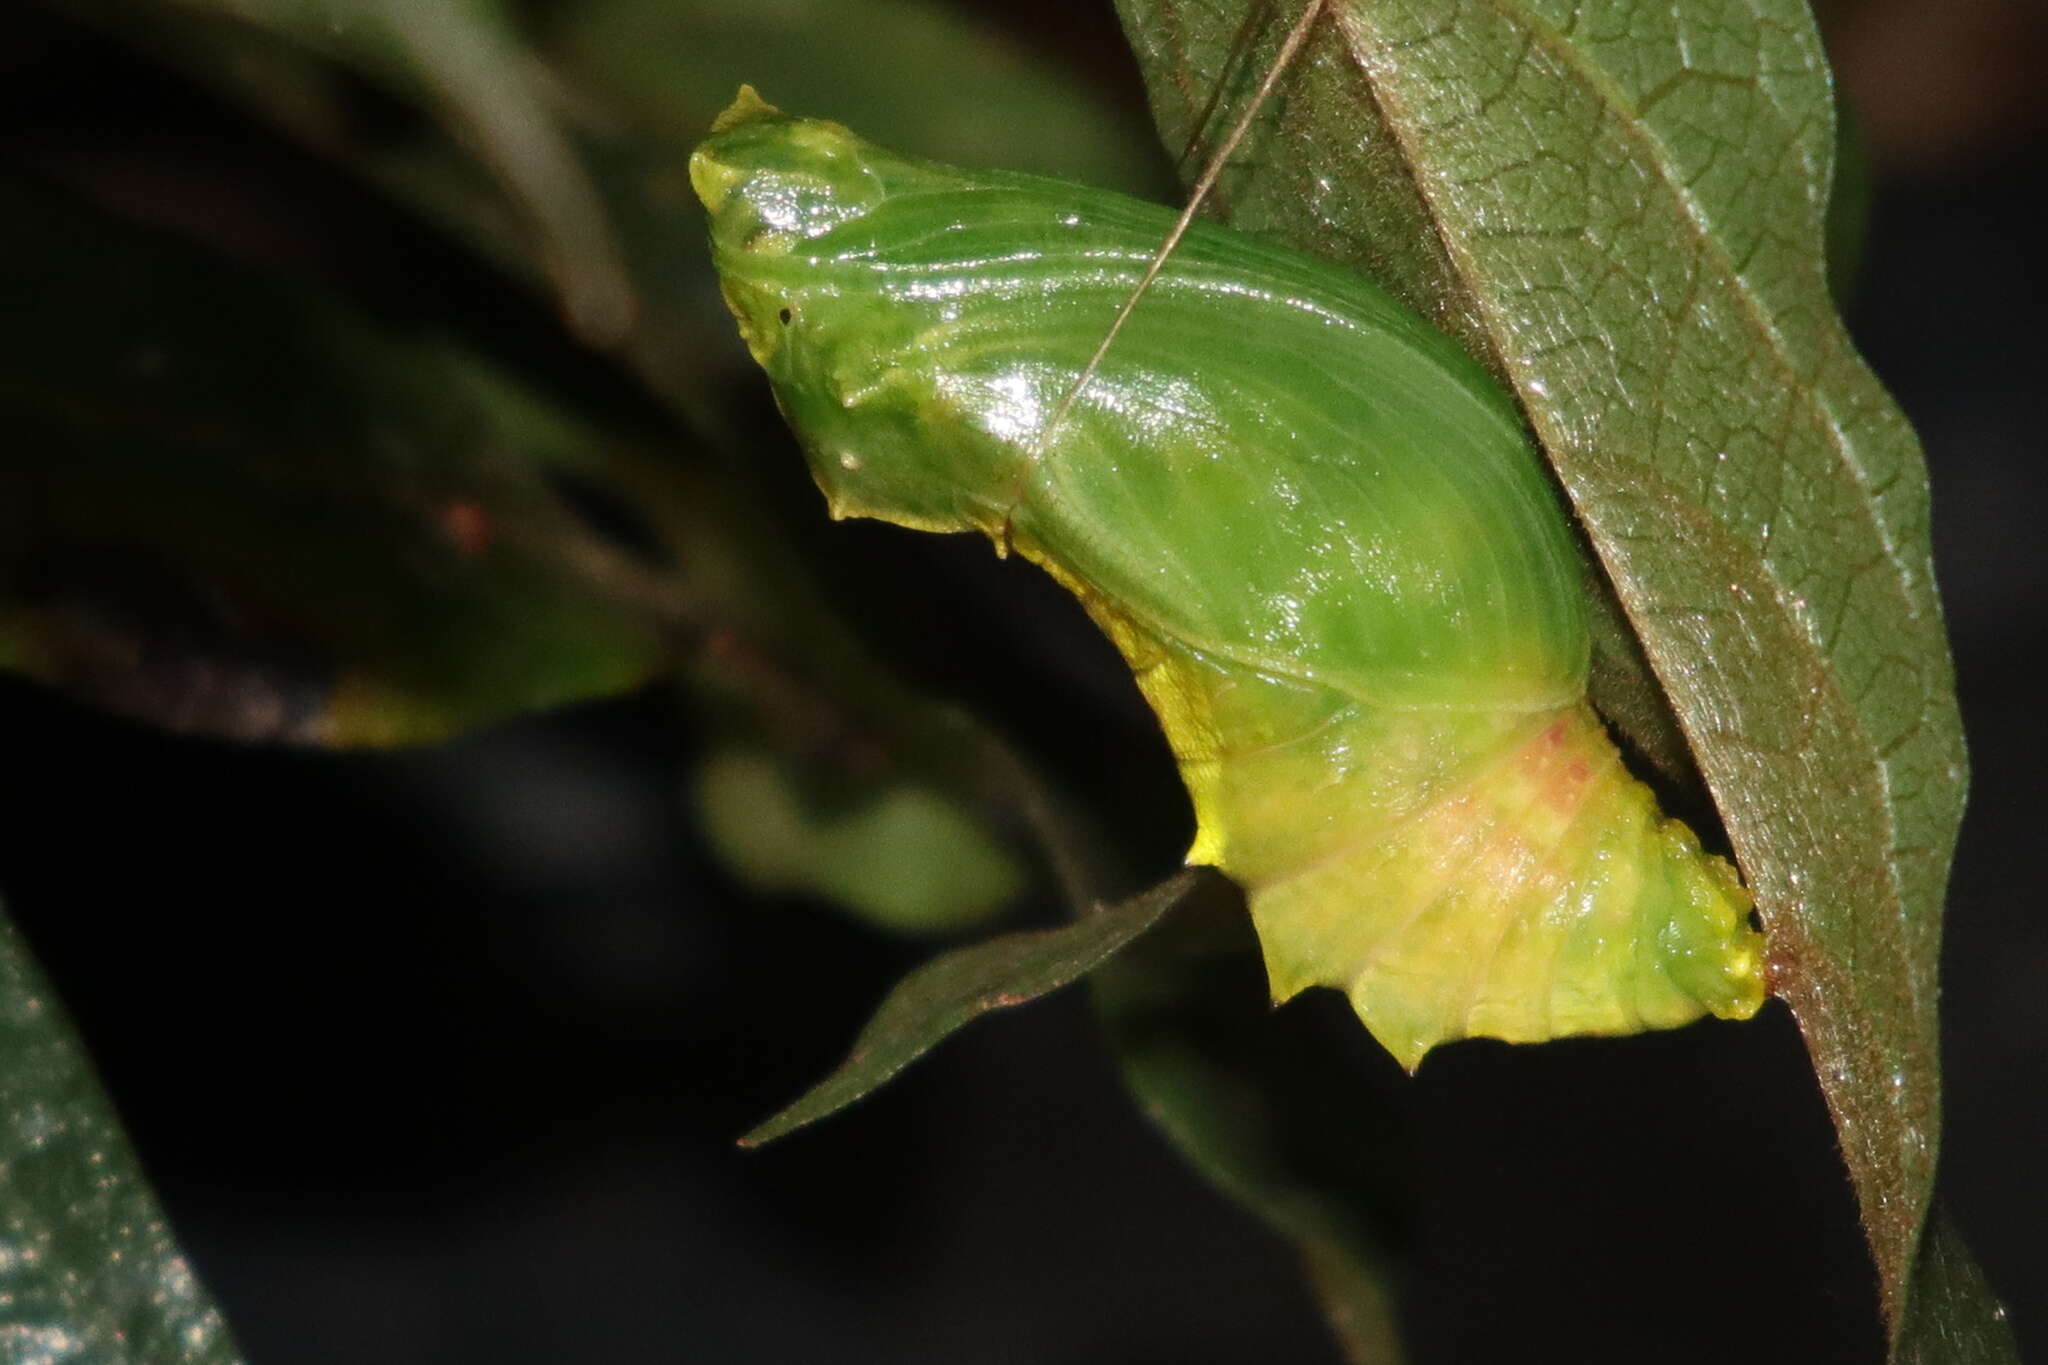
[690,92,1763,1066]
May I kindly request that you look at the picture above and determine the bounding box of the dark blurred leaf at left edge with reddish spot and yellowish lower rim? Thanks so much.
[0,182,674,743]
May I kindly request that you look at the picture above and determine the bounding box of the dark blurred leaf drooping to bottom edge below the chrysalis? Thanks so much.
[1090,896,1405,1365]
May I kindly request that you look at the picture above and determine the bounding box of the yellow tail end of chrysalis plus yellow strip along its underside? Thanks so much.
[1032,540,1765,1070]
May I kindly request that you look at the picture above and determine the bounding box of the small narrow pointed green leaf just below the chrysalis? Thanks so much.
[739,872,1200,1146]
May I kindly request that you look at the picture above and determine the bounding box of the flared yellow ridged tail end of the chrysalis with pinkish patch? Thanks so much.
[1236,704,1765,1070]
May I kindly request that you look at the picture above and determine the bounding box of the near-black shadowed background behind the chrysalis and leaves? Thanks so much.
[0,0,2048,1365]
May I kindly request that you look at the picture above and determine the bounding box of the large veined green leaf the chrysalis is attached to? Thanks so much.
[1120,0,1964,1324]
